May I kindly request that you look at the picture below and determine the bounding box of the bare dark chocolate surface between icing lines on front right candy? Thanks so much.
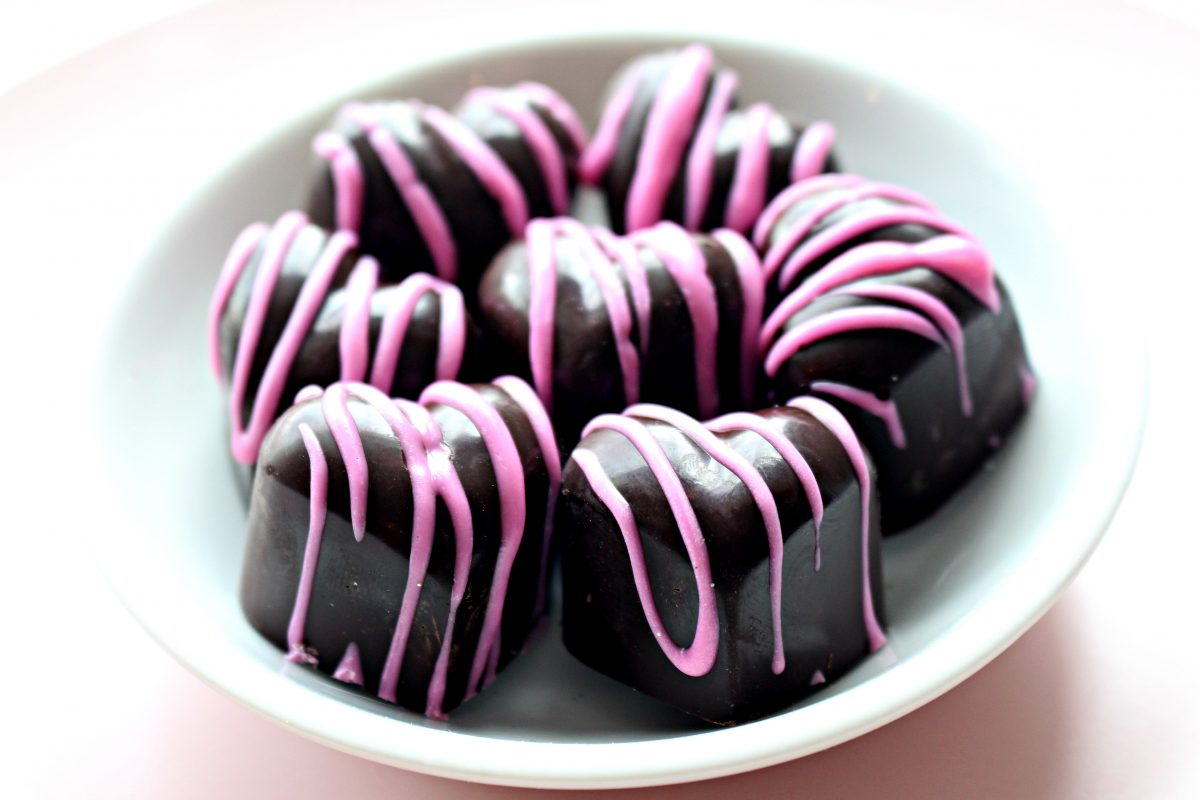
[557,408,882,723]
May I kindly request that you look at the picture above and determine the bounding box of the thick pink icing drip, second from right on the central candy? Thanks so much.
[630,222,720,419]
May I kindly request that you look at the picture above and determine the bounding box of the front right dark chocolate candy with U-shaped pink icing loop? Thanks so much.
[557,397,884,723]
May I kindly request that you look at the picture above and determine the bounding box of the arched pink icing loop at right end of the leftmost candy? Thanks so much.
[362,272,467,392]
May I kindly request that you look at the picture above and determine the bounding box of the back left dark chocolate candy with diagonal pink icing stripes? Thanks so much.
[308,83,586,292]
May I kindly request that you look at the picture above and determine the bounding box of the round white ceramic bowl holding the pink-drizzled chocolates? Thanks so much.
[91,29,1144,787]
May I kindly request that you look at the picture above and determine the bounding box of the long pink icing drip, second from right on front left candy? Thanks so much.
[420,381,526,697]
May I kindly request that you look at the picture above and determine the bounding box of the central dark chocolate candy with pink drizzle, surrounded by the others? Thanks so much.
[480,218,762,449]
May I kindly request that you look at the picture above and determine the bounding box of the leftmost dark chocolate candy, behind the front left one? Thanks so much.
[210,211,477,472]
